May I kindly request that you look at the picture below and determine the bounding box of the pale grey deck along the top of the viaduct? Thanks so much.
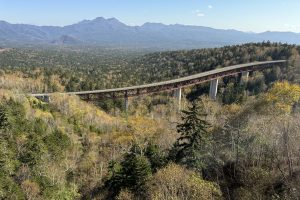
[31,60,286,97]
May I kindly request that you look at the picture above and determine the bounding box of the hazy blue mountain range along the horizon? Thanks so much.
[0,17,300,49]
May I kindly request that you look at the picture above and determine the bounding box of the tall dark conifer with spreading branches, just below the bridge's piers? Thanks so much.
[170,101,210,172]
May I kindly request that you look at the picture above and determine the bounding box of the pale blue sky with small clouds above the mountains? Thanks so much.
[0,0,300,33]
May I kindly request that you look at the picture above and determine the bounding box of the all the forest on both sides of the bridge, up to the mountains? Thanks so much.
[0,43,300,200]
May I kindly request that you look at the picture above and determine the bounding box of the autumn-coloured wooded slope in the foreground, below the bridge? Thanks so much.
[0,82,300,199]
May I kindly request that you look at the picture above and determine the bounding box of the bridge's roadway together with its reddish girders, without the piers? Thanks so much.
[31,60,287,100]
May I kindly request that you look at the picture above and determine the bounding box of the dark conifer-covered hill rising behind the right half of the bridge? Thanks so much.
[129,43,300,82]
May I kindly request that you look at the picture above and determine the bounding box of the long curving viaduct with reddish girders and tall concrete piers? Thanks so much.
[31,60,287,110]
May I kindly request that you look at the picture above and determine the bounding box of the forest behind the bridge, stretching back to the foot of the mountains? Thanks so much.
[0,43,300,92]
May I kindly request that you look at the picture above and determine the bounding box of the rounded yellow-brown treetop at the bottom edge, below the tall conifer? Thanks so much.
[148,164,221,200]
